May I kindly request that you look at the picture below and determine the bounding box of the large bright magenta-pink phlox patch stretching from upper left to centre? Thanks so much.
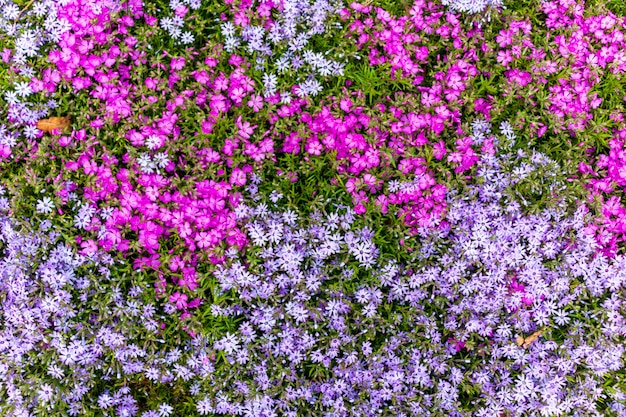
[4,2,489,314]
